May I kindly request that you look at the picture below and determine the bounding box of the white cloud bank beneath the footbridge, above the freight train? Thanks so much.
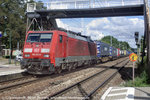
[57,17,144,48]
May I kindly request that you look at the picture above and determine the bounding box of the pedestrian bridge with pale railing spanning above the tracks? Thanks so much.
[27,0,144,18]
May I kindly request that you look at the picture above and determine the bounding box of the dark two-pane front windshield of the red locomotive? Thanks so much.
[27,33,52,42]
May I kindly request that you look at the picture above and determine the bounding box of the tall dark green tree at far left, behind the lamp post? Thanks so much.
[0,0,26,49]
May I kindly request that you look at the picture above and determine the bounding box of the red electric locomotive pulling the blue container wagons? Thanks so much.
[21,29,96,74]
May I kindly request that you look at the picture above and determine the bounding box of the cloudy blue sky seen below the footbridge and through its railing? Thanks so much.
[32,0,144,48]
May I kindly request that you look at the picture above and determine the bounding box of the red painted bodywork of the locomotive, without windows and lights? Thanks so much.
[23,30,96,66]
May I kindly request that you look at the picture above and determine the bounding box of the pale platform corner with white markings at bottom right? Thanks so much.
[100,87,150,100]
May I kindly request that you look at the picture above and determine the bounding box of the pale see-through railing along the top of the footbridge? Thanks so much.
[27,0,144,12]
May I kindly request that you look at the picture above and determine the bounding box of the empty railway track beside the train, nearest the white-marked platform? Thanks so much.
[45,60,129,100]
